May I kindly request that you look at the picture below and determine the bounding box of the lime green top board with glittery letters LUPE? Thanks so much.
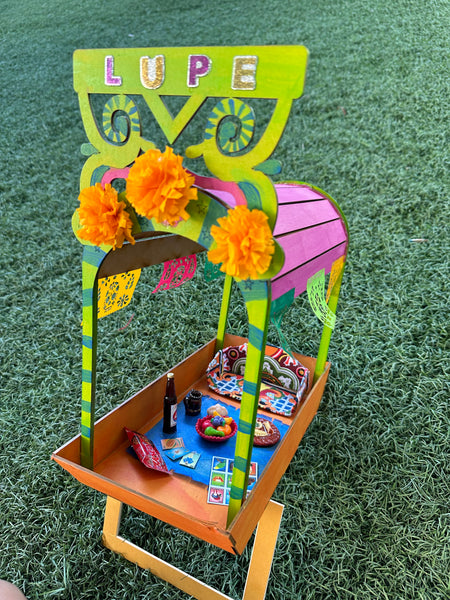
[73,46,308,98]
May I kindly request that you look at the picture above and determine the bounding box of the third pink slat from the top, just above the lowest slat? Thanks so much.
[275,220,347,275]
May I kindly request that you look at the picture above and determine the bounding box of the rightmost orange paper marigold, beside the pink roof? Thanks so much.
[208,205,275,279]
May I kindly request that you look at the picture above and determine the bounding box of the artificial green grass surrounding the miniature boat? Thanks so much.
[0,0,450,600]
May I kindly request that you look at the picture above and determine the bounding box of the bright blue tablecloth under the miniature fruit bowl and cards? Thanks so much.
[145,396,288,485]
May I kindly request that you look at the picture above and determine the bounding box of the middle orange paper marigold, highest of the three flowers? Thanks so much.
[127,146,197,225]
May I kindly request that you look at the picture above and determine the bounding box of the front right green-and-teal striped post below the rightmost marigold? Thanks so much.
[227,280,270,525]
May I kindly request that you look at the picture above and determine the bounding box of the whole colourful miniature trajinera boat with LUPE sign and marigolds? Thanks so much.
[53,46,348,598]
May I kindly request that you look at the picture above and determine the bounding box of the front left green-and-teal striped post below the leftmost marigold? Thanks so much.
[80,246,106,469]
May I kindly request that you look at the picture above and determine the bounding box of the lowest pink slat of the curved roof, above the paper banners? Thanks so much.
[272,242,347,301]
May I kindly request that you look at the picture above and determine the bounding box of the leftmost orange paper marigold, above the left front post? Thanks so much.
[77,183,134,250]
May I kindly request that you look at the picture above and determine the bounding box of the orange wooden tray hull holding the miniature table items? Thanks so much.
[52,335,330,554]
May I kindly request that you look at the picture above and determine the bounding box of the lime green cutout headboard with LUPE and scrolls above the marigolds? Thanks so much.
[74,46,308,230]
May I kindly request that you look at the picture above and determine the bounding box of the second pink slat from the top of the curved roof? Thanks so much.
[273,200,340,236]
